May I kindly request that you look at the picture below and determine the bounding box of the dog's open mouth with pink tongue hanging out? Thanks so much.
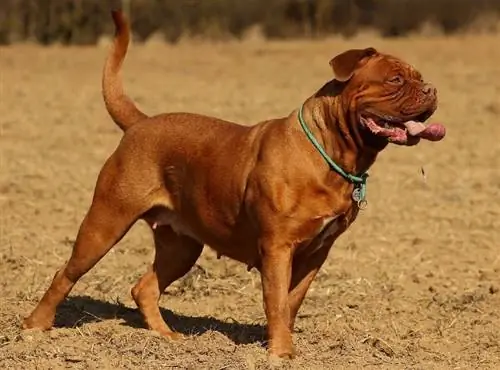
[360,111,446,146]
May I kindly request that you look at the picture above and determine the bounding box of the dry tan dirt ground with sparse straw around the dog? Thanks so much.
[0,35,500,369]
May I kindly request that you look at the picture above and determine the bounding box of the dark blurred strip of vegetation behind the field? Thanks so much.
[0,0,500,45]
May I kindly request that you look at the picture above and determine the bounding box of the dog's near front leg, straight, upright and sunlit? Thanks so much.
[261,240,295,358]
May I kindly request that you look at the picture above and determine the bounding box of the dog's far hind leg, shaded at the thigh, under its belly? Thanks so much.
[132,226,203,339]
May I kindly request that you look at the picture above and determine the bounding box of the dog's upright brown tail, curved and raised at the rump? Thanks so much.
[102,10,148,131]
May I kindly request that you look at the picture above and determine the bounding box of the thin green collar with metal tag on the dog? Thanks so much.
[299,104,368,209]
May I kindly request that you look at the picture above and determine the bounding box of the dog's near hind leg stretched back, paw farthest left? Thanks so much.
[22,156,162,330]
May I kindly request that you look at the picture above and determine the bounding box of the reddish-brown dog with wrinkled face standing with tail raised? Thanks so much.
[23,11,444,357]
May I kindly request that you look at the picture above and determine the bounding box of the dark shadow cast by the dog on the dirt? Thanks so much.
[54,296,265,344]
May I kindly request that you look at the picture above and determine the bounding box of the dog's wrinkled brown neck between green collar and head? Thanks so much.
[304,80,387,175]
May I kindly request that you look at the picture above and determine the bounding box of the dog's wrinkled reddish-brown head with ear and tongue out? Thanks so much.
[330,48,445,145]
